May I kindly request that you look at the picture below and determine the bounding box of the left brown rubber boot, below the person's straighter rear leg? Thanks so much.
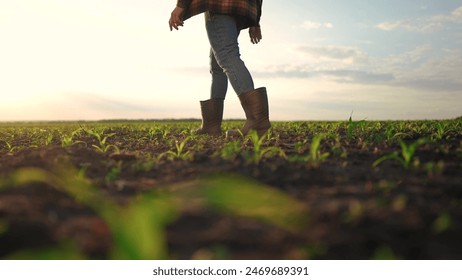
[196,98,224,136]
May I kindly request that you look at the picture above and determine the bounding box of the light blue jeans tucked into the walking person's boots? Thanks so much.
[205,12,254,99]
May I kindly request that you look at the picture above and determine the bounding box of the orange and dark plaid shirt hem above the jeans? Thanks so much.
[177,0,263,28]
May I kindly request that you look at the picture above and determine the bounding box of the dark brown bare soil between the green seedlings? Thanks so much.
[0,123,462,260]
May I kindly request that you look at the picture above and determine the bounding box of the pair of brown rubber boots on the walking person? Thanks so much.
[196,87,271,137]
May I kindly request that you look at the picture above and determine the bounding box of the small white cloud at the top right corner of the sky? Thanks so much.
[376,6,462,33]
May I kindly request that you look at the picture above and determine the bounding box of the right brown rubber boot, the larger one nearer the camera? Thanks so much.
[227,87,271,137]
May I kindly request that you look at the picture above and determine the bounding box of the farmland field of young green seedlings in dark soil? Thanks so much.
[0,118,462,259]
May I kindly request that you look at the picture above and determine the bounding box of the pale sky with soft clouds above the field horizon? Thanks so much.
[0,0,462,121]
